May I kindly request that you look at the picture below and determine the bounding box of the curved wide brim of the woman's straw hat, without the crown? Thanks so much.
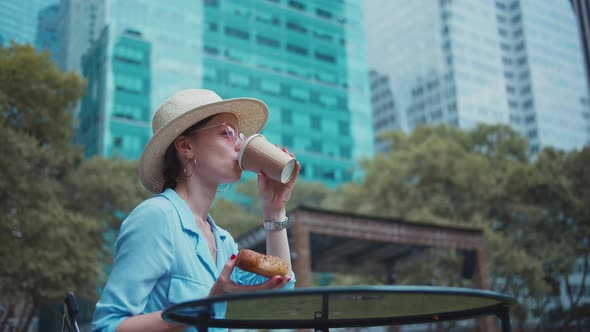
[139,98,268,193]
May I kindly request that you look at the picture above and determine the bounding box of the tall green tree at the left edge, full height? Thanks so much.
[0,43,88,330]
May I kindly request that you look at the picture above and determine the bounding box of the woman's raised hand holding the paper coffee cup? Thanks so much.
[258,147,301,220]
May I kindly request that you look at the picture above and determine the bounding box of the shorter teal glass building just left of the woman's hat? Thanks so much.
[75,27,151,159]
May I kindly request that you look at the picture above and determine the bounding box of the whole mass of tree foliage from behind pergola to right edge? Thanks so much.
[338,125,590,321]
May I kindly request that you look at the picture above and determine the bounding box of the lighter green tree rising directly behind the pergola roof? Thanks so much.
[340,125,545,319]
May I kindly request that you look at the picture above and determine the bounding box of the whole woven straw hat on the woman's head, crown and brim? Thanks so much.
[139,89,268,193]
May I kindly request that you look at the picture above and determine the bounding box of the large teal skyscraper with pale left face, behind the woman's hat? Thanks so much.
[71,0,373,185]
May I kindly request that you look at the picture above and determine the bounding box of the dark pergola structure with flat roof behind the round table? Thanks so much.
[237,206,493,331]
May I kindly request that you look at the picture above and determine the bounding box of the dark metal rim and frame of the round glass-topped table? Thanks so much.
[162,286,516,332]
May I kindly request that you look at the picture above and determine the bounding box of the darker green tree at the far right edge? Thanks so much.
[514,147,590,331]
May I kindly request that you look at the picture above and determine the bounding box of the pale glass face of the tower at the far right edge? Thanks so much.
[513,0,590,150]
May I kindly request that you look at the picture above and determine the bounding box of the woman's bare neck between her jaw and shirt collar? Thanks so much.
[174,176,217,221]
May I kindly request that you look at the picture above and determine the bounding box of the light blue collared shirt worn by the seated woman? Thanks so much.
[92,189,295,332]
